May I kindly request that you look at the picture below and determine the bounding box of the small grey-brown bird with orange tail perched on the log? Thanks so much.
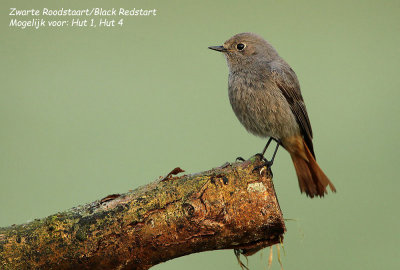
[208,33,336,198]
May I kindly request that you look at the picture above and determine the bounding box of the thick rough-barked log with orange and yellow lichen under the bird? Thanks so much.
[0,157,285,269]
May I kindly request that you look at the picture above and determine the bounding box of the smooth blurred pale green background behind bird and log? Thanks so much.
[0,0,400,270]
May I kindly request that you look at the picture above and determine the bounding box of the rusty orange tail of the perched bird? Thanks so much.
[288,139,336,198]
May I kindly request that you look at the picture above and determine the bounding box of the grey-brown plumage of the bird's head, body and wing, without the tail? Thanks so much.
[224,33,313,156]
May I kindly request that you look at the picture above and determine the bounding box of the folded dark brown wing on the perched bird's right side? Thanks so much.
[271,63,315,157]
